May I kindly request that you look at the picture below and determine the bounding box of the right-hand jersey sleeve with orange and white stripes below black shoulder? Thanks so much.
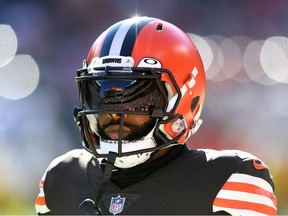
[213,153,277,215]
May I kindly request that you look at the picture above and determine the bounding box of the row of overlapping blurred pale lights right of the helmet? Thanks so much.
[189,33,288,85]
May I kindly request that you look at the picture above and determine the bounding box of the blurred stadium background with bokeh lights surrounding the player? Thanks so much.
[0,0,288,215]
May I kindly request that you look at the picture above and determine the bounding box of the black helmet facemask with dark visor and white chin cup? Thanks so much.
[76,66,181,168]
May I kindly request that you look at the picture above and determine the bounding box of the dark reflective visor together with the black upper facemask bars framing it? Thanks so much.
[76,67,173,117]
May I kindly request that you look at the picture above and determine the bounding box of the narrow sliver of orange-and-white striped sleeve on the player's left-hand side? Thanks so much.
[35,171,51,215]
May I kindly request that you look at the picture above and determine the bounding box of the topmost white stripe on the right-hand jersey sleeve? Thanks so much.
[227,173,273,193]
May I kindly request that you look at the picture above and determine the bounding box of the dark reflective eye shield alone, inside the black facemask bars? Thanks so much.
[82,80,163,114]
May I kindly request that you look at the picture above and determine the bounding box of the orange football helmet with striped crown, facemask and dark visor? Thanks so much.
[75,17,206,167]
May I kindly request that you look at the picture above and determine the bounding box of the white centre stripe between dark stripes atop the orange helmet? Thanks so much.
[109,22,134,55]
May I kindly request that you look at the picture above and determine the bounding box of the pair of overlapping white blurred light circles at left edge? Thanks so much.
[0,25,39,100]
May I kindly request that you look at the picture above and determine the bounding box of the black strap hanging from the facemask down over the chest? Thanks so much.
[78,152,117,215]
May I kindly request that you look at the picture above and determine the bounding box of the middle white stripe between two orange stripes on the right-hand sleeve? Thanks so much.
[217,190,277,210]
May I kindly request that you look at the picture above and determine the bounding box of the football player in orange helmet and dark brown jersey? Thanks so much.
[36,17,277,215]
